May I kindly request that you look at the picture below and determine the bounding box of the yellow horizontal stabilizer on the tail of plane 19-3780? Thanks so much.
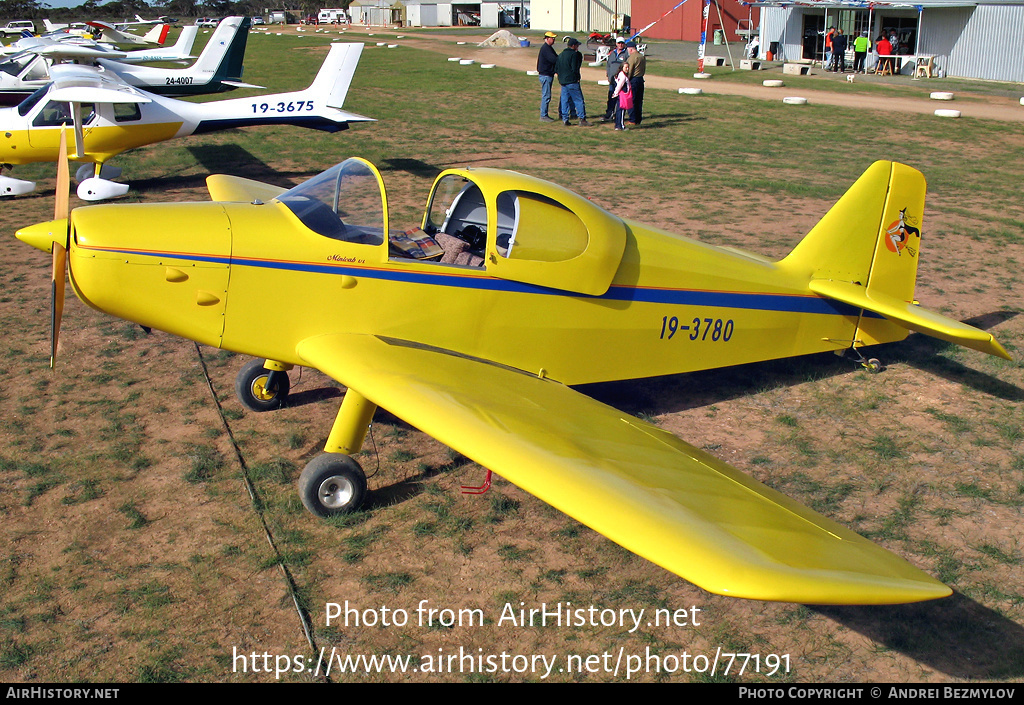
[809,279,1012,360]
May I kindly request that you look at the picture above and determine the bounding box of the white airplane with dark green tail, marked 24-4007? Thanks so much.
[0,17,245,106]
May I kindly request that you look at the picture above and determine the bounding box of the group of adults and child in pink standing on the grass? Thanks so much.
[537,32,647,130]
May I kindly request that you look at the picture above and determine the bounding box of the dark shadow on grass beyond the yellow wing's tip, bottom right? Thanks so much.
[810,592,1024,680]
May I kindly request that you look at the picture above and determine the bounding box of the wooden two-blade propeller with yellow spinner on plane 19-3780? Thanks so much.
[16,130,71,368]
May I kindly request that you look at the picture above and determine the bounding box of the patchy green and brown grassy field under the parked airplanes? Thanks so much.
[0,28,1024,683]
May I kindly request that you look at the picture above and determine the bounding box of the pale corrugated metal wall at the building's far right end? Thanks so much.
[919,5,1024,82]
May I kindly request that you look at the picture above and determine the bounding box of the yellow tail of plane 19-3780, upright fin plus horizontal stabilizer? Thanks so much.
[779,162,1010,359]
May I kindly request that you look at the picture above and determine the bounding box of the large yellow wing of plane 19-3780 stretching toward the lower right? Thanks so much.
[298,334,950,605]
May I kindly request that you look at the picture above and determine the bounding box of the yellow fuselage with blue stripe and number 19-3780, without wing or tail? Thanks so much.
[64,196,884,384]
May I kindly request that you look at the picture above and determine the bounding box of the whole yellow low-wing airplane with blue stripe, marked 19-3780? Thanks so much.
[17,152,1009,604]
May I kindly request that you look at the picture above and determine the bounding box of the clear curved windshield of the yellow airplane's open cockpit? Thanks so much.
[279,159,384,245]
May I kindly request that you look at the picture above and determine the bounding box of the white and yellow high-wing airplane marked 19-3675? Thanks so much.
[0,44,373,201]
